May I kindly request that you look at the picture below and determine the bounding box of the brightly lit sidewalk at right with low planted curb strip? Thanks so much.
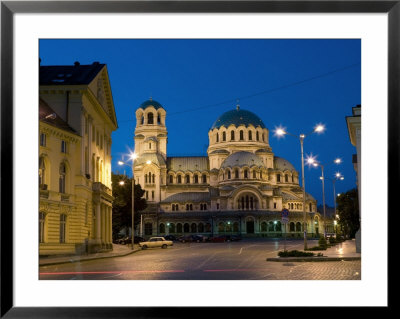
[267,239,361,262]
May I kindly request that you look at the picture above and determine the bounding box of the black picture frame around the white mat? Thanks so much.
[0,0,394,318]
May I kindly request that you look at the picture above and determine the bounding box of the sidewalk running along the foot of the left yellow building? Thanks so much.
[39,244,140,266]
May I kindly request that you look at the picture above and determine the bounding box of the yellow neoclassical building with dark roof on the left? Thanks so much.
[38,62,117,255]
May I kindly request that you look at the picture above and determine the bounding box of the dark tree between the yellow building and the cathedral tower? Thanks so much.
[111,173,147,238]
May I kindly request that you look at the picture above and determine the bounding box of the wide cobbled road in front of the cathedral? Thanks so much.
[39,239,361,280]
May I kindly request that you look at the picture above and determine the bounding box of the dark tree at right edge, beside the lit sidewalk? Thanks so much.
[336,188,360,238]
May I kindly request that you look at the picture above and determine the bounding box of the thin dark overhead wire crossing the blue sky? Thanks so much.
[120,63,361,123]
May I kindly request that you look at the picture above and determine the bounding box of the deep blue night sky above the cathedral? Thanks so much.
[39,40,361,206]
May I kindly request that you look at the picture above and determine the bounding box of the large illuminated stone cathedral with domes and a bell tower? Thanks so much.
[133,99,323,238]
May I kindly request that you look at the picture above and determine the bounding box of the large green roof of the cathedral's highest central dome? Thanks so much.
[211,109,265,129]
